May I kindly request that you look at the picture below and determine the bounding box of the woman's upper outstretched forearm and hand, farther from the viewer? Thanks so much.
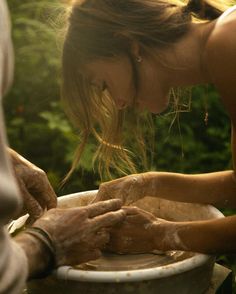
[93,171,236,208]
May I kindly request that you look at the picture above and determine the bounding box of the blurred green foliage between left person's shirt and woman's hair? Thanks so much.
[4,0,98,195]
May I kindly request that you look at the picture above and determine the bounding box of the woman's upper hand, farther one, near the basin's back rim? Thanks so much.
[92,174,147,205]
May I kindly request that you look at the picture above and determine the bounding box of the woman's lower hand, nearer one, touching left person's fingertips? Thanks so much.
[106,207,169,253]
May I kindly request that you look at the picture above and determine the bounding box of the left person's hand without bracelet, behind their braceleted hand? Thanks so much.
[8,148,57,222]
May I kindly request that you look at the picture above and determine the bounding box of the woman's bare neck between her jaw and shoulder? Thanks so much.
[158,21,215,87]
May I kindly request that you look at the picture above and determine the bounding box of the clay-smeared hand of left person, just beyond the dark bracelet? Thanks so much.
[33,200,126,266]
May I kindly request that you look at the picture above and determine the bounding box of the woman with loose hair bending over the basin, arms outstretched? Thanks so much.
[62,0,236,253]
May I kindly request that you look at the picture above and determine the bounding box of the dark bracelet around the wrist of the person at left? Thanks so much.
[24,227,56,277]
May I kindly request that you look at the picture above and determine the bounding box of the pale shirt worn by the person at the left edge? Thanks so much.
[0,0,28,294]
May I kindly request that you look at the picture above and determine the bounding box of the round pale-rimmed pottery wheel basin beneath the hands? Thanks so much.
[27,191,224,294]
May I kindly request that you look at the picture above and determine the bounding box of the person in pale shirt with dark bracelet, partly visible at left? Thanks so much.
[0,0,125,294]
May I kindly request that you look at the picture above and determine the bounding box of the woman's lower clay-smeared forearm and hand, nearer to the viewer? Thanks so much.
[107,207,236,254]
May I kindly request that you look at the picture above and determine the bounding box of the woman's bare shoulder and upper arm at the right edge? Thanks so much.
[205,10,236,120]
